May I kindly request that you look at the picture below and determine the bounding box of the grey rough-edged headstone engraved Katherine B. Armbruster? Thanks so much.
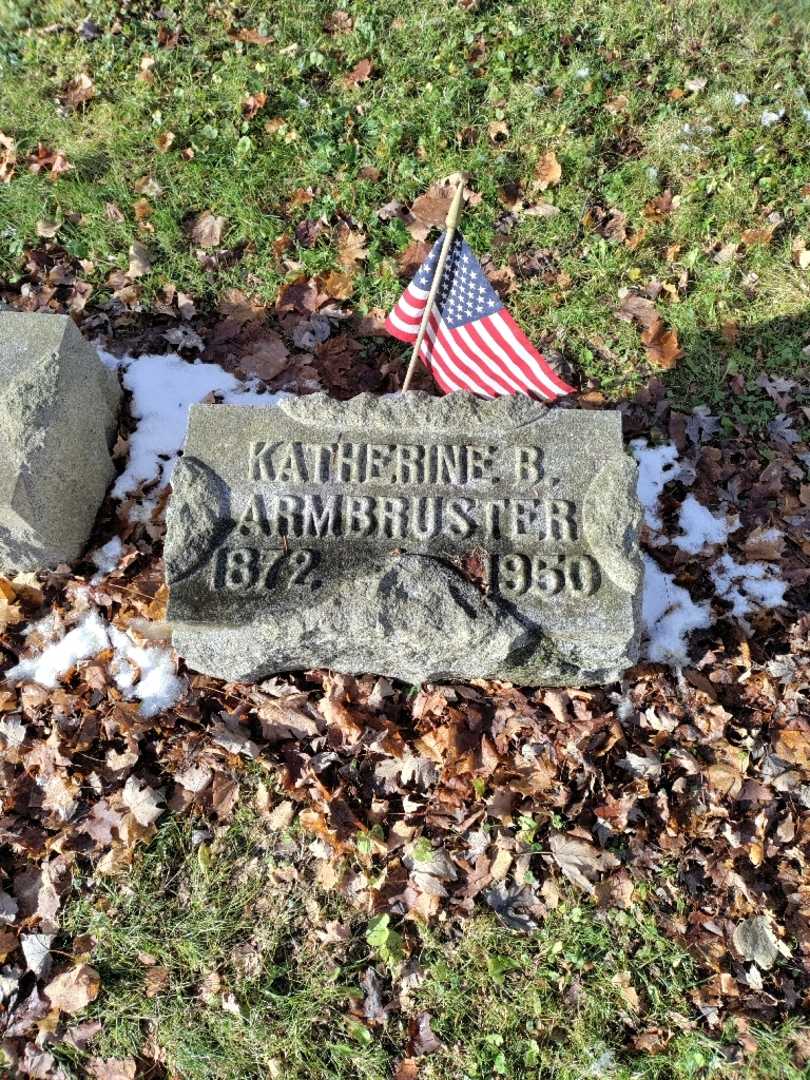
[165,393,642,685]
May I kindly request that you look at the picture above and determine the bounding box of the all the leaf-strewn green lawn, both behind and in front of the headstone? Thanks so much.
[0,0,810,1080]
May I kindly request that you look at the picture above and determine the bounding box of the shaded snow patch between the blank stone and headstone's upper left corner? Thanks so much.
[99,350,280,499]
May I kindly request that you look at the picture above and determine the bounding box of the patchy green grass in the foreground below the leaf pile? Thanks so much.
[57,804,801,1080]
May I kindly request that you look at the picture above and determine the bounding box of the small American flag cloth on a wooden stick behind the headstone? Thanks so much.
[386,234,573,400]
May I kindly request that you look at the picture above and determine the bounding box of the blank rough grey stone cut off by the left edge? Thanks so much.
[0,311,121,572]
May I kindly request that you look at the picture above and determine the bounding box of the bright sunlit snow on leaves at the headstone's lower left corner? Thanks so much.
[5,611,185,716]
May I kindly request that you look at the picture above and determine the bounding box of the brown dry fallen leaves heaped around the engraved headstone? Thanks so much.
[0,185,810,1076]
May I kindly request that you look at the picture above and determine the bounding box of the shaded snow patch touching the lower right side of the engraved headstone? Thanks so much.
[642,555,712,666]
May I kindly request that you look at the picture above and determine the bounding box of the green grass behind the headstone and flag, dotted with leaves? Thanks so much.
[0,0,810,423]
